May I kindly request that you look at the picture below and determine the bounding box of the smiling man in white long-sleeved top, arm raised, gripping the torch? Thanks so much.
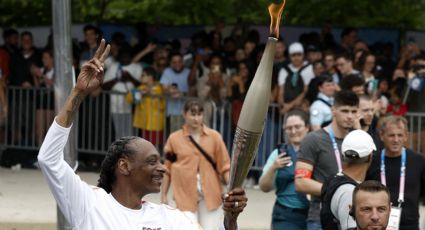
[38,40,247,230]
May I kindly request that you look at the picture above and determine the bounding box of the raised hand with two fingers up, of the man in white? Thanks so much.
[75,39,110,95]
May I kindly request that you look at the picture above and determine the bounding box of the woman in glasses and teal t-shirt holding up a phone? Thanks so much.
[260,109,309,230]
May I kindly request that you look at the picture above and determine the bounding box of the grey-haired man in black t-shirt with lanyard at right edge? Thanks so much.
[366,116,425,230]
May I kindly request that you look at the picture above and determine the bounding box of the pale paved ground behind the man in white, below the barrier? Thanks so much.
[0,167,274,230]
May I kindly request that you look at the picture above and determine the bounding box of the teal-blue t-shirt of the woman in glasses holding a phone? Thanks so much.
[261,145,309,209]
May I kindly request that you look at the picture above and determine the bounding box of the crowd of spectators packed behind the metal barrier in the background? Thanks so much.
[0,22,425,160]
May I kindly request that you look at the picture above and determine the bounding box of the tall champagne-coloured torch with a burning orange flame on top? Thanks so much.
[229,0,285,190]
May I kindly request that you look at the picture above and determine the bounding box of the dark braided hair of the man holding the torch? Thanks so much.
[97,136,139,193]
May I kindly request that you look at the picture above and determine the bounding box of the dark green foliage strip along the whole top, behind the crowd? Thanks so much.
[0,0,425,29]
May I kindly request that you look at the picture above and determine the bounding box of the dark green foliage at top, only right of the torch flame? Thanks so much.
[287,0,425,29]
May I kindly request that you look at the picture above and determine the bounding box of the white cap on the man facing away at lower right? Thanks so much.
[341,129,376,158]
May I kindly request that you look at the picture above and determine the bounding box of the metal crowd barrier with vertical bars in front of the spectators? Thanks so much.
[0,87,425,170]
